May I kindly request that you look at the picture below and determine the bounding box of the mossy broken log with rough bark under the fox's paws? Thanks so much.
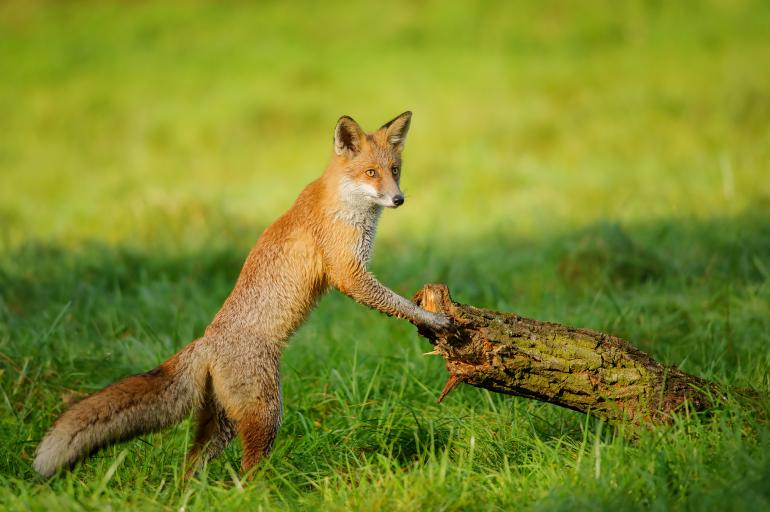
[414,285,724,425]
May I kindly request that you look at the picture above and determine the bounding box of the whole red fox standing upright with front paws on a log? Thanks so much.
[34,111,451,477]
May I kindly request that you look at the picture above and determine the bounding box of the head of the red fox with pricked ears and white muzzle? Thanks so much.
[334,111,412,208]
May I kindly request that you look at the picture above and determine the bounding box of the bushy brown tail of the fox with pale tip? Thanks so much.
[33,344,199,477]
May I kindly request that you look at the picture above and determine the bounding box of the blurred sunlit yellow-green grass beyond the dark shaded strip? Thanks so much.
[0,1,770,240]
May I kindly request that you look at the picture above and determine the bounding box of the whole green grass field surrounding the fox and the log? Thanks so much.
[0,0,770,511]
